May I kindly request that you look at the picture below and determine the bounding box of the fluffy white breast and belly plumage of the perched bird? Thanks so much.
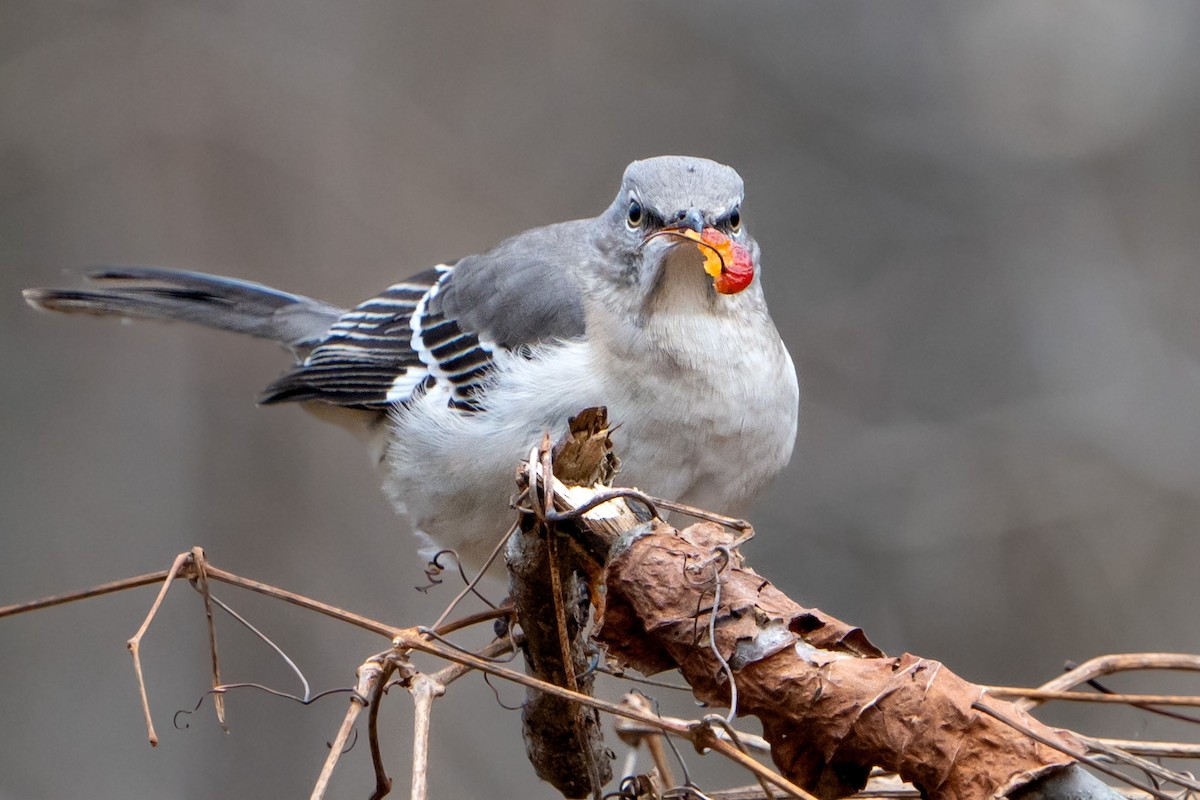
[386,298,798,565]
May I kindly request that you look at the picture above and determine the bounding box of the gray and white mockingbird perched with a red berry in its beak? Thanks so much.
[24,156,799,566]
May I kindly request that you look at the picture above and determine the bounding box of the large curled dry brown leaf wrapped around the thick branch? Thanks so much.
[596,523,1082,800]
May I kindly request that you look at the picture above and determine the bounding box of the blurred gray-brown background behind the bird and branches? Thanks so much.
[0,0,1200,799]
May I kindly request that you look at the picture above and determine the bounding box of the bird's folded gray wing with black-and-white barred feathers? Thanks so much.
[262,225,583,411]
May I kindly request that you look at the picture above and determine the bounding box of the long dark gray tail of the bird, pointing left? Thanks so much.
[24,267,344,354]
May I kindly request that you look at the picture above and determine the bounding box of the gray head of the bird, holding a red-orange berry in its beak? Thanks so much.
[602,156,758,303]
